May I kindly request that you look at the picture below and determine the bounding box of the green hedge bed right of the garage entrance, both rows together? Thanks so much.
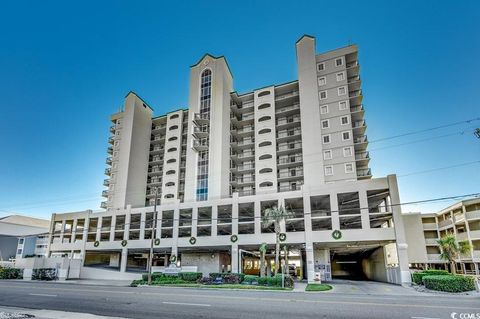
[412,270,475,292]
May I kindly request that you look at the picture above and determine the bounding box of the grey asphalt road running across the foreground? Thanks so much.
[0,281,480,319]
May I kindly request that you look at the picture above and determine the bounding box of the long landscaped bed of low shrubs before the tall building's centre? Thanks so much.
[130,272,293,290]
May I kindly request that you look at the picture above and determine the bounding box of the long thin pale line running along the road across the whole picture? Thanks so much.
[1,285,480,310]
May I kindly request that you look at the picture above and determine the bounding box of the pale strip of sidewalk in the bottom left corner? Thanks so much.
[0,306,125,319]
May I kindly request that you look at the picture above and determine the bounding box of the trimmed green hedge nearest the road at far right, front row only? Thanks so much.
[423,275,475,292]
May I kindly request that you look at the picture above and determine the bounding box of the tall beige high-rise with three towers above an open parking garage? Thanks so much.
[49,36,410,283]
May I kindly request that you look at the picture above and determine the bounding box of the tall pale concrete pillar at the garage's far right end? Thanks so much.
[387,175,412,284]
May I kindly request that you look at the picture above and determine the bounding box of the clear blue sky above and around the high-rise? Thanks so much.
[0,1,480,218]
